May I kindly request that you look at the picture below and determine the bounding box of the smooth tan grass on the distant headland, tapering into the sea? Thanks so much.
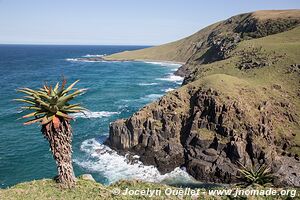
[105,10,300,62]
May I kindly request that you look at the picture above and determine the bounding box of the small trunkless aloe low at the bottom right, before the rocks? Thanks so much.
[239,163,274,185]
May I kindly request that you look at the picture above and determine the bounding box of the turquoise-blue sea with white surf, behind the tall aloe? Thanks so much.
[0,45,191,188]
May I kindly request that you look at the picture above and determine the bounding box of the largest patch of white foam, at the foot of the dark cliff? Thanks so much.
[74,139,194,183]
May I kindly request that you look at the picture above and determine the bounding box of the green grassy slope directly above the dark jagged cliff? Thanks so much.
[179,27,300,154]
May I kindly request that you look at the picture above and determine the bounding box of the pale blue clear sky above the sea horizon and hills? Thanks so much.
[0,0,300,45]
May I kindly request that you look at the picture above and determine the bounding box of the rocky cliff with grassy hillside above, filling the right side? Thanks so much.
[106,10,300,186]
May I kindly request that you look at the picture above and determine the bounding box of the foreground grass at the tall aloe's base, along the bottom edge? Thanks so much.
[0,179,300,200]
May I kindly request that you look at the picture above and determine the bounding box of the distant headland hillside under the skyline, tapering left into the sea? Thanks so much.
[105,10,300,62]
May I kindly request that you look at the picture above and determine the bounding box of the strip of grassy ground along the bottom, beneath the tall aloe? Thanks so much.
[0,179,300,200]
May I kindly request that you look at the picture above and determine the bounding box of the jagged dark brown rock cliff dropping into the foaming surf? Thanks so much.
[106,75,300,186]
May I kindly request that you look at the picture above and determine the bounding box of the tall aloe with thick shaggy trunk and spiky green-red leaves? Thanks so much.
[15,80,85,188]
